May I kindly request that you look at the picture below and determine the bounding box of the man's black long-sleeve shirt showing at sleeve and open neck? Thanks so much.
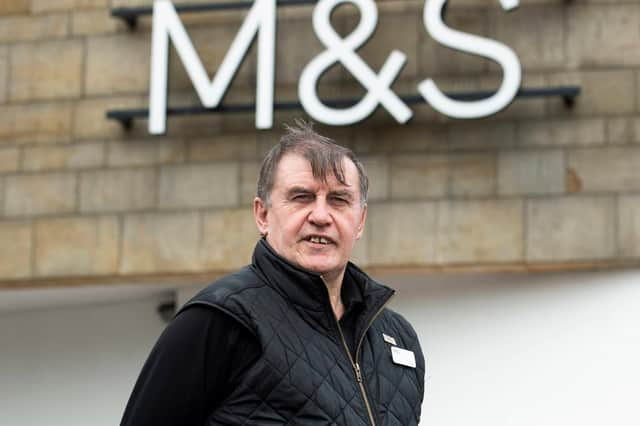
[121,275,362,426]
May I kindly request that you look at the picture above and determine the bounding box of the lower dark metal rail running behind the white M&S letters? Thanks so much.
[106,86,581,130]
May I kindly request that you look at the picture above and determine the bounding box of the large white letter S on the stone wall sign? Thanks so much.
[418,0,522,118]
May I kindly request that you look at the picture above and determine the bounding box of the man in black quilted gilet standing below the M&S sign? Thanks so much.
[122,122,424,426]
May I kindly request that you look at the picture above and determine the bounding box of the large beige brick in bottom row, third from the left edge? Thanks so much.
[120,212,201,274]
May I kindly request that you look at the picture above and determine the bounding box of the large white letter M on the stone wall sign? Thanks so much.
[149,0,276,135]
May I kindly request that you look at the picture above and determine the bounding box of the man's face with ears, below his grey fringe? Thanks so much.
[254,154,366,281]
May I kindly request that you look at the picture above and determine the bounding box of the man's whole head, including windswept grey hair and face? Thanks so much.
[254,121,368,280]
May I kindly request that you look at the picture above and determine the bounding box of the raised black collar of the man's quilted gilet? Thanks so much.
[252,238,394,332]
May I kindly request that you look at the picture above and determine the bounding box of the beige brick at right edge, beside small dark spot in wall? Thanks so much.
[567,147,640,191]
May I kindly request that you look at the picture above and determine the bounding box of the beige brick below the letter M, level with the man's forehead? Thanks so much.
[158,163,239,208]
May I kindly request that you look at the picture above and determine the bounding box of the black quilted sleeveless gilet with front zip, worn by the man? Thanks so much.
[182,240,425,426]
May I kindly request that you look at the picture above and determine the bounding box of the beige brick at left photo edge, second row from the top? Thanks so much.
[0,14,68,43]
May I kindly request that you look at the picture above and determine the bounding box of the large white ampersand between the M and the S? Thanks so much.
[298,0,413,126]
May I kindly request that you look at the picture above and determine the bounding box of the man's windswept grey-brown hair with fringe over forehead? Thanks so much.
[257,119,369,206]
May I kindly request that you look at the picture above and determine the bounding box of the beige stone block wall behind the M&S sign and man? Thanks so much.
[0,0,640,287]
